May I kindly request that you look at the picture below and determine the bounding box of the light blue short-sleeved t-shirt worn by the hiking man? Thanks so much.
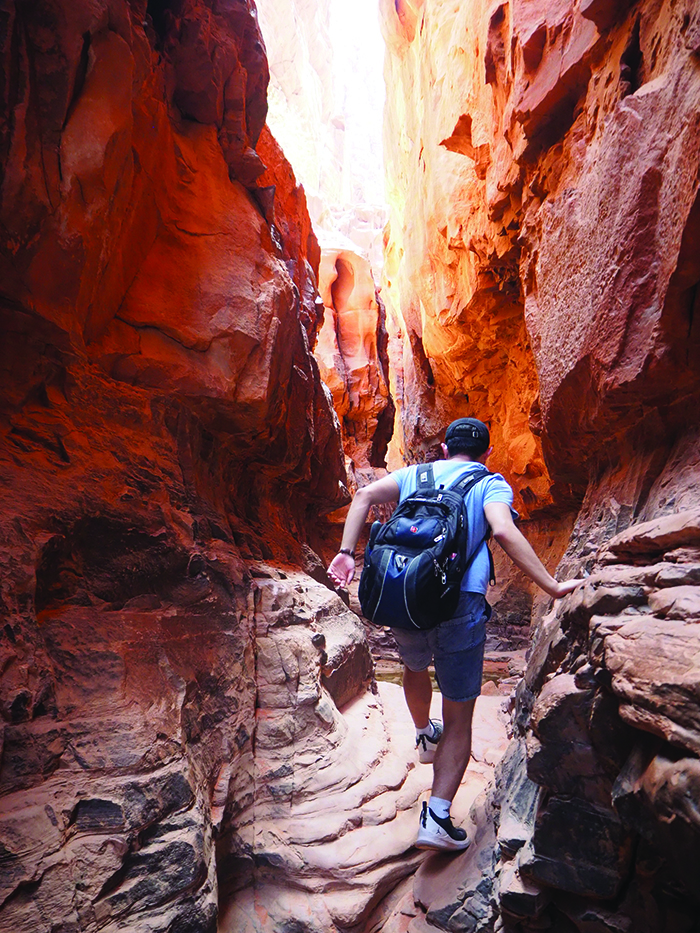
[391,460,518,596]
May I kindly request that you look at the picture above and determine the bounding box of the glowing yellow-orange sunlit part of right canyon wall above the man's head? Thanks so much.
[383,3,552,514]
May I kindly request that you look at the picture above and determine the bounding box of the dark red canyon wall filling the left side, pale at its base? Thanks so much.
[0,0,410,933]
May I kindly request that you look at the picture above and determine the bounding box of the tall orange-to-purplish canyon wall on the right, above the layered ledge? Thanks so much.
[382,0,700,624]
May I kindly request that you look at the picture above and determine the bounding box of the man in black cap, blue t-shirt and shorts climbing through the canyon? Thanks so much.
[328,418,581,850]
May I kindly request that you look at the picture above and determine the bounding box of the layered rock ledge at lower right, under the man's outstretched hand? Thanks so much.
[400,510,700,933]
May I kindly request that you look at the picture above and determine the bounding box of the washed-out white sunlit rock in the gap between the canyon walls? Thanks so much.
[257,0,386,274]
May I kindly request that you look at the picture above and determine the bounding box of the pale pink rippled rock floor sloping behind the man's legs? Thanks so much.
[220,684,506,933]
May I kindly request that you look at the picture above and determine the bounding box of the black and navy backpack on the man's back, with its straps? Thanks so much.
[359,463,493,630]
